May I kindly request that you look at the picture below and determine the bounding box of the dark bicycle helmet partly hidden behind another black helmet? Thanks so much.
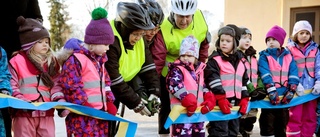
[136,0,164,26]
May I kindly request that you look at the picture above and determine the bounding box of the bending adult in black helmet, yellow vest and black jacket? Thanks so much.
[105,2,160,135]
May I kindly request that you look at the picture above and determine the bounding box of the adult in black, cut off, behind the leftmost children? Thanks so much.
[0,0,43,137]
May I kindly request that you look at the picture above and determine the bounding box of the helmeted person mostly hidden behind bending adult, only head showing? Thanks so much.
[136,0,164,45]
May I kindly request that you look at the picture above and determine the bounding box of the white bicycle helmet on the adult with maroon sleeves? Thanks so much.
[171,0,198,16]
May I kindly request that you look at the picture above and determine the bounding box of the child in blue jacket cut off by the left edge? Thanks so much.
[0,46,12,137]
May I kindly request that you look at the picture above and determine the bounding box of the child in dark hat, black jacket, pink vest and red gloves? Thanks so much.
[205,26,249,137]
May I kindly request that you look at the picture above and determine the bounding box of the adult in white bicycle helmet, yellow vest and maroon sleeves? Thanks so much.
[151,0,211,136]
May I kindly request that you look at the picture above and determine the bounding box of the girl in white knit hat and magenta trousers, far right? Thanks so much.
[287,20,320,137]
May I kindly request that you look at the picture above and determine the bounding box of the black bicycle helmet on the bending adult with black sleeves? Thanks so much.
[115,2,154,30]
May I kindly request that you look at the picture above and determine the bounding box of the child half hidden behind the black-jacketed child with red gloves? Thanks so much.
[238,28,266,137]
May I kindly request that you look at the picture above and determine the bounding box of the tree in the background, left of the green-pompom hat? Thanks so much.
[48,0,71,51]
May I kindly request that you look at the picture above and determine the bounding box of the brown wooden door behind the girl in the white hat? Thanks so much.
[290,6,320,44]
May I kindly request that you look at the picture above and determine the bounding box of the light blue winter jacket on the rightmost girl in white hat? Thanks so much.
[288,40,320,89]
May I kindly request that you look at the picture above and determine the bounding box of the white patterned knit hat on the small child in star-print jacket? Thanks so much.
[179,35,199,59]
